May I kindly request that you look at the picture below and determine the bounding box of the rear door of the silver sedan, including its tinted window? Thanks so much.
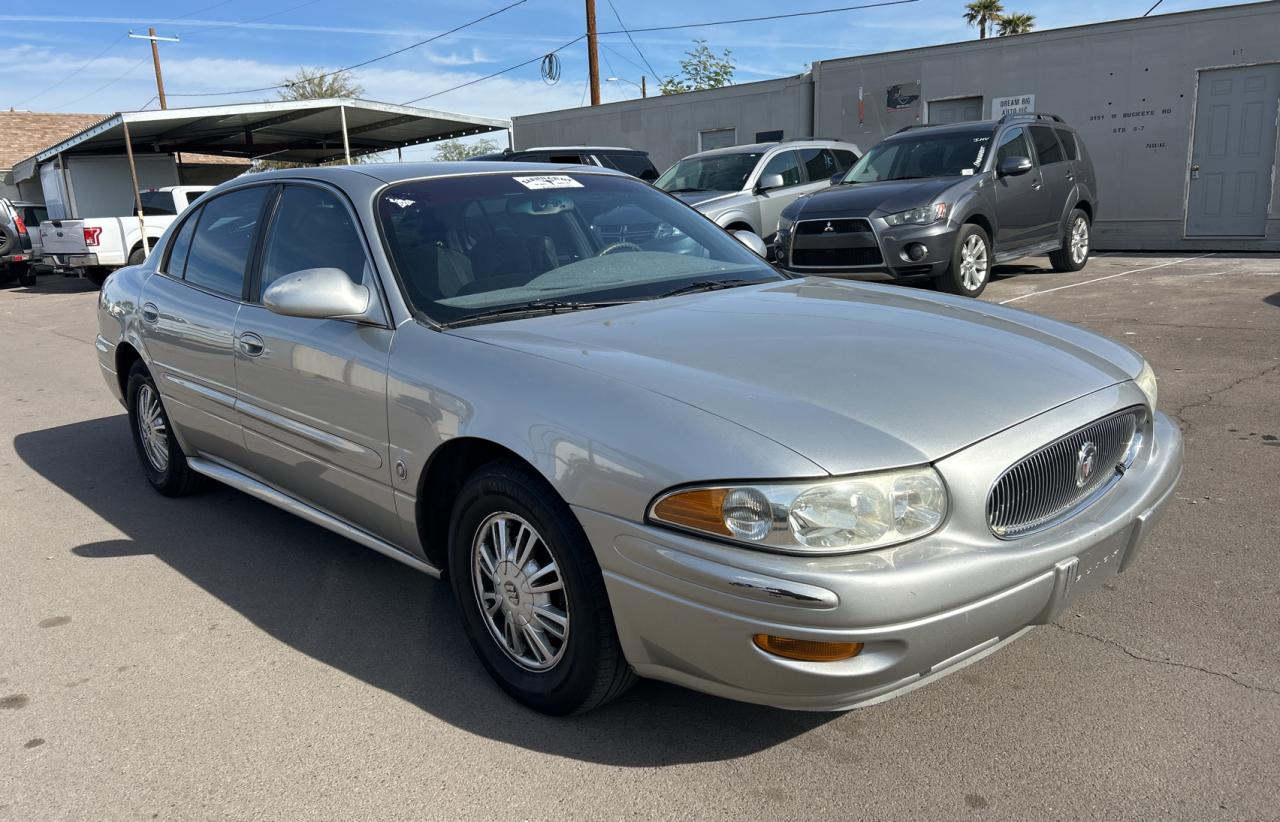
[140,186,275,466]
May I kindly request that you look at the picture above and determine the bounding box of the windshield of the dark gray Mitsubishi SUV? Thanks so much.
[844,131,995,183]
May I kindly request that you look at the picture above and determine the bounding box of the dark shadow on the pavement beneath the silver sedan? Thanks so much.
[14,416,835,767]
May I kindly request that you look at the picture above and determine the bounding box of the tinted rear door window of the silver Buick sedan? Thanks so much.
[184,186,273,298]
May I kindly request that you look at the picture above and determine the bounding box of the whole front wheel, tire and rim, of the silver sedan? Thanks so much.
[449,462,635,716]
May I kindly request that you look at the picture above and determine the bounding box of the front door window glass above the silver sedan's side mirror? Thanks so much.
[261,186,369,291]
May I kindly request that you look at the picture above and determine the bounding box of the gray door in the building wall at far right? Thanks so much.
[1187,64,1280,237]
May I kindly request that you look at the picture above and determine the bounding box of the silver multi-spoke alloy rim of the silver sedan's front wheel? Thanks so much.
[471,511,570,671]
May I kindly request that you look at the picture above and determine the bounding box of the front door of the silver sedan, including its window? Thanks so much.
[236,184,401,542]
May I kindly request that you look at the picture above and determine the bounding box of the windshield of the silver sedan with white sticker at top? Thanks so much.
[378,172,782,324]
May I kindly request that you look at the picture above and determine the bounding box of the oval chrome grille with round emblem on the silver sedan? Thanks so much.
[987,408,1143,539]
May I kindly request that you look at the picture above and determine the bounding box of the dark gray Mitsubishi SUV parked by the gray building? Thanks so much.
[777,114,1098,297]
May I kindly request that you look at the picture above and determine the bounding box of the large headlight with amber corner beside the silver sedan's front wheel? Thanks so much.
[649,466,947,553]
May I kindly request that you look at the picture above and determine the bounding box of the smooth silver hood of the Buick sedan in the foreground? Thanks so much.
[449,278,1140,474]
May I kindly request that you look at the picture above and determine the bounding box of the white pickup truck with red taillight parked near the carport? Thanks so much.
[40,186,212,286]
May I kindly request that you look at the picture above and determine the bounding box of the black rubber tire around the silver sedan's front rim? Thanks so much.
[448,461,635,716]
